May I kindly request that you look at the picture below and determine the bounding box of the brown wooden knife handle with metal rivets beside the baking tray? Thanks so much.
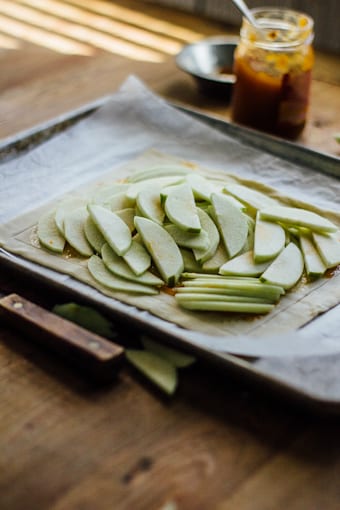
[0,294,124,381]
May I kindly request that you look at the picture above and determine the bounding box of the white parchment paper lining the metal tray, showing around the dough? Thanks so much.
[0,77,340,408]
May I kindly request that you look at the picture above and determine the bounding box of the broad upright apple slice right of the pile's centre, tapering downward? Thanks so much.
[211,193,248,257]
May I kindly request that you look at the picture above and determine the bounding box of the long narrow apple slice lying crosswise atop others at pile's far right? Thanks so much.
[259,206,338,233]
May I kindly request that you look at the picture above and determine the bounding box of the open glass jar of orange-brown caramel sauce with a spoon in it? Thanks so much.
[232,8,314,139]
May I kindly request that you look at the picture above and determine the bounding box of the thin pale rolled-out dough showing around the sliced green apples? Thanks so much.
[0,149,340,344]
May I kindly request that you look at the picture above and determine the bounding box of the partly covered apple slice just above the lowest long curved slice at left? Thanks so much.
[101,243,164,287]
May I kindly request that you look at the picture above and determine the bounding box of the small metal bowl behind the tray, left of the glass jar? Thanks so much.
[176,36,238,101]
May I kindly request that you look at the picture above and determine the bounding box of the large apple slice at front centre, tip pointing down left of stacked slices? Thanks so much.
[135,216,184,287]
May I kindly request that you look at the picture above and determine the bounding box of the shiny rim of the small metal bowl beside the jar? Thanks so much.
[175,35,240,85]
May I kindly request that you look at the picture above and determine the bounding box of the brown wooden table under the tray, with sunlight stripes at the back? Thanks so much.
[0,0,340,510]
